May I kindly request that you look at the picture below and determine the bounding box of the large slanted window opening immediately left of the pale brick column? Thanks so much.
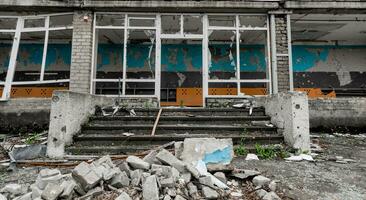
[44,29,72,80]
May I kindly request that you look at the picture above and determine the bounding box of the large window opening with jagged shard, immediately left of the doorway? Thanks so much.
[126,30,156,79]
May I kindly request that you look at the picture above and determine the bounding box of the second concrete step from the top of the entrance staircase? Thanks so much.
[89,116,271,126]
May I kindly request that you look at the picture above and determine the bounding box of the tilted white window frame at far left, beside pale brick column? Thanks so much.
[0,13,74,100]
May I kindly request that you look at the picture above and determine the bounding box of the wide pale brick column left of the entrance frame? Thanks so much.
[70,11,93,93]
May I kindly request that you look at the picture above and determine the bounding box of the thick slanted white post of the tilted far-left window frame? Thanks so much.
[1,18,24,100]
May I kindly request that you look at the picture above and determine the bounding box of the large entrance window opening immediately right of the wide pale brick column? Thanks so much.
[96,29,124,79]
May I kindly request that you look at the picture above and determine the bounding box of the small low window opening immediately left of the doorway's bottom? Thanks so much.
[125,82,155,95]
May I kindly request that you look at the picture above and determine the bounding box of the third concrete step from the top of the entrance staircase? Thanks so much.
[82,124,277,135]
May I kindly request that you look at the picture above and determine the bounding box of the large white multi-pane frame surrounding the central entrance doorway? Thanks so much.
[90,12,272,106]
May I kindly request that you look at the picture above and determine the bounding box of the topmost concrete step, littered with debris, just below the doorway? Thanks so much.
[96,108,265,116]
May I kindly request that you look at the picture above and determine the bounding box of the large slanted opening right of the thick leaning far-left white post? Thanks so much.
[14,31,45,81]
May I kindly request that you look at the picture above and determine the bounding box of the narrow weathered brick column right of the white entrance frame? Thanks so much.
[274,14,291,92]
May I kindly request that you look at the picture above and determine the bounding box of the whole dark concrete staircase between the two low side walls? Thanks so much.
[66,108,283,155]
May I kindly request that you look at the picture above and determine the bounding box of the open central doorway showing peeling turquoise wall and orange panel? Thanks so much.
[160,39,203,106]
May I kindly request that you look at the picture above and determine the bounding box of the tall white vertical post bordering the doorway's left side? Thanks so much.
[154,14,161,104]
